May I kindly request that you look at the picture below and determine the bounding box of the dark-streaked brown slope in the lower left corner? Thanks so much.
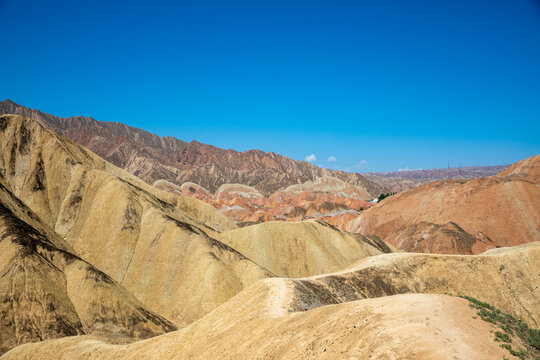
[0,178,176,354]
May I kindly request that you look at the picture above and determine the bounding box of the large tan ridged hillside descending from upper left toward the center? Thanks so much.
[0,116,272,325]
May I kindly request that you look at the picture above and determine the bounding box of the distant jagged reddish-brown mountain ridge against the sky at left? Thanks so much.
[0,100,387,197]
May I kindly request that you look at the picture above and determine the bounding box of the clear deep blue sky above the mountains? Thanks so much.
[0,0,540,171]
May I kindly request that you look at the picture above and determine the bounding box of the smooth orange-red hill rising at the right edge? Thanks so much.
[346,155,540,253]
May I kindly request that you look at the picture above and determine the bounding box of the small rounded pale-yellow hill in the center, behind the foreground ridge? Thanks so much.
[219,220,391,277]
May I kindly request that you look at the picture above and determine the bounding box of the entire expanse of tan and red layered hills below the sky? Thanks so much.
[0,102,540,360]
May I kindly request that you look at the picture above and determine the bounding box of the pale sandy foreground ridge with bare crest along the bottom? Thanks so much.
[4,243,540,360]
